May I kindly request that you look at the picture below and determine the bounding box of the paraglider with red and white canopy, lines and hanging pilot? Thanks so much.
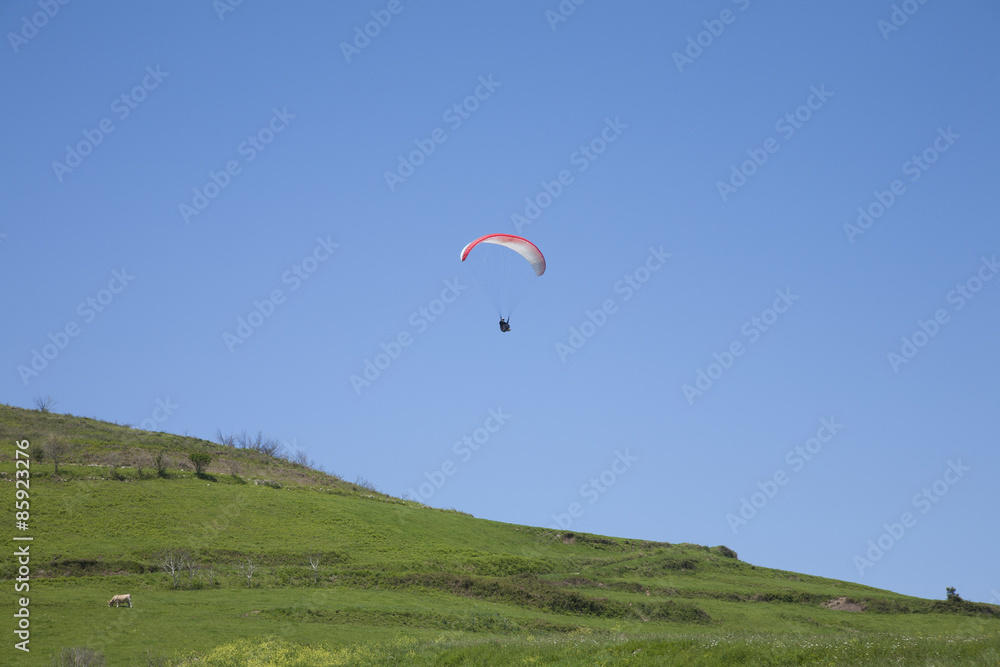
[460,234,545,333]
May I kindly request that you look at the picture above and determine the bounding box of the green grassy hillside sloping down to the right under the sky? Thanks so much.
[0,405,1000,667]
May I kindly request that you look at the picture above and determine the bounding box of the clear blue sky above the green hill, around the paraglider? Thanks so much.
[0,0,1000,602]
